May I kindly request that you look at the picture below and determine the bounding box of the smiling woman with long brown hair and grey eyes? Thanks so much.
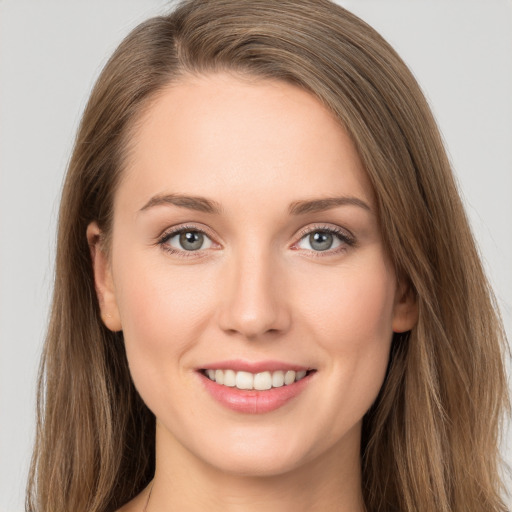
[28,0,507,512]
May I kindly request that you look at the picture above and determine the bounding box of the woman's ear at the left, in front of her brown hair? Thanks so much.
[87,222,122,332]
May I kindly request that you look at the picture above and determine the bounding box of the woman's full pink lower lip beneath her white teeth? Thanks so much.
[199,372,315,414]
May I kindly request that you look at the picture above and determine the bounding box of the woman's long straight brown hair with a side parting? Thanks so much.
[27,0,508,512]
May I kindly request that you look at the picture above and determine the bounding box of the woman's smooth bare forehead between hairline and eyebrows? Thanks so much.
[118,73,372,213]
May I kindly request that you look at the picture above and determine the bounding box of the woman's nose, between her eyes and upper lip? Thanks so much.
[218,245,291,340]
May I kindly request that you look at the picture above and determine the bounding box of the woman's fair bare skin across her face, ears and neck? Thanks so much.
[87,74,417,512]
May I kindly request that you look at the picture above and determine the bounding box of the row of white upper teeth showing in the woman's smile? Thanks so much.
[205,369,307,391]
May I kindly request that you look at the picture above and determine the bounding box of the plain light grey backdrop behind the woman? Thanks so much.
[0,0,512,512]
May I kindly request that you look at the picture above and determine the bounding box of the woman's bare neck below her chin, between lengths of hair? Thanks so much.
[147,422,365,512]
